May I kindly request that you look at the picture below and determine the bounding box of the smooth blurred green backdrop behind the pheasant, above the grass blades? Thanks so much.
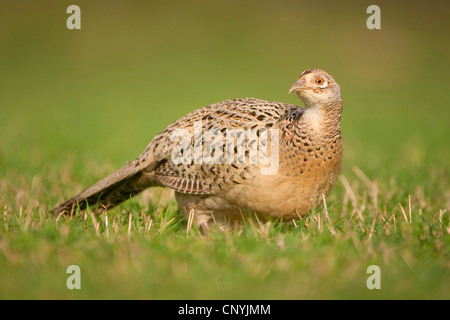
[0,0,450,297]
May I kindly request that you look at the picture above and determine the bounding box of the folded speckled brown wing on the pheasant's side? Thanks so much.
[147,98,299,195]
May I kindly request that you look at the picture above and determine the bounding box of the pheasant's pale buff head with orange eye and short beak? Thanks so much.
[289,69,341,107]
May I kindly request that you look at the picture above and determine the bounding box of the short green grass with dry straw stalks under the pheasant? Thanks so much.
[0,169,450,299]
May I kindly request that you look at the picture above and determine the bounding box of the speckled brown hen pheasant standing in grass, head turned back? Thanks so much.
[52,69,343,228]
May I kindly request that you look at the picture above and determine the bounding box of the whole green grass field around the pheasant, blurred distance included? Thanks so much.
[0,0,450,299]
